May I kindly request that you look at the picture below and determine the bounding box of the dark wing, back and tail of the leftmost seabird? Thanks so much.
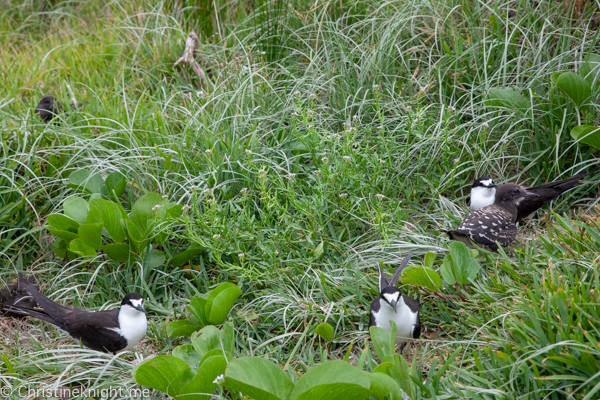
[11,287,127,353]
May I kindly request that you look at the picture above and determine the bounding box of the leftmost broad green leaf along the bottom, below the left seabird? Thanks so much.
[133,356,195,397]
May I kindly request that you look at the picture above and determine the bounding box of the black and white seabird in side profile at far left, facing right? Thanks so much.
[9,286,148,353]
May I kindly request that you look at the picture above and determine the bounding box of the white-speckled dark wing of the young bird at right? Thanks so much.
[448,204,517,251]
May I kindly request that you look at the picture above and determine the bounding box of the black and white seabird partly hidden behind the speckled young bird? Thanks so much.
[470,172,589,222]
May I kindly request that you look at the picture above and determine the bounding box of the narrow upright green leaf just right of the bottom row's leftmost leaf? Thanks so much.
[177,355,227,400]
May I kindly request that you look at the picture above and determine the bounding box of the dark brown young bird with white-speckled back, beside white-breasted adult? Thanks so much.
[446,183,540,251]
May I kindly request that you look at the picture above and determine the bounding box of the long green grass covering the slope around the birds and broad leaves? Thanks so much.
[0,0,600,399]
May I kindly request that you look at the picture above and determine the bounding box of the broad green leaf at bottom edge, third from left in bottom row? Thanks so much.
[225,357,294,400]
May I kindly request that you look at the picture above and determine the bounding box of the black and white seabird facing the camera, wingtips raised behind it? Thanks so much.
[369,252,421,353]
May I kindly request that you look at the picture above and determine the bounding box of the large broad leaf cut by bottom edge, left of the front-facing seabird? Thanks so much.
[290,360,371,400]
